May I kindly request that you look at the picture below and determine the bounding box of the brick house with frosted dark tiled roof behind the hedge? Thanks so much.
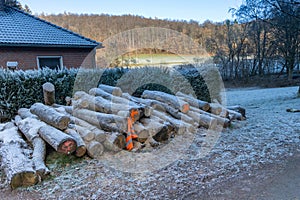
[0,0,101,70]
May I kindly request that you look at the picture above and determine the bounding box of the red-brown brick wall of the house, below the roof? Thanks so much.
[0,47,95,70]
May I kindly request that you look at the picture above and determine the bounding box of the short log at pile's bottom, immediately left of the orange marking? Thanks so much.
[103,132,126,152]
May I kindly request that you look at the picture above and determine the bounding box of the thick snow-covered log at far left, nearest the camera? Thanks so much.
[0,127,38,189]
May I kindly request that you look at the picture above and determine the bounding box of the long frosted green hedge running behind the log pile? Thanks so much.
[0,65,220,120]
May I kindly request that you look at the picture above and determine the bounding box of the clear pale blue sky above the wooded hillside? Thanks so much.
[19,0,242,23]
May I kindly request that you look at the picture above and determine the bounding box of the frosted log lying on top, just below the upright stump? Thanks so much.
[30,103,70,131]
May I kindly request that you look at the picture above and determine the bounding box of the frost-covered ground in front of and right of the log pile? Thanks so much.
[0,87,300,199]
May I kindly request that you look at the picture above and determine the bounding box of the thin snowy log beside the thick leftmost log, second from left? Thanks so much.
[16,118,50,178]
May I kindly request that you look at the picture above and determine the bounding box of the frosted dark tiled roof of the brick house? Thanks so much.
[0,7,101,48]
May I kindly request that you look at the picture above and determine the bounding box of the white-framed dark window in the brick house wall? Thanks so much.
[37,56,63,69]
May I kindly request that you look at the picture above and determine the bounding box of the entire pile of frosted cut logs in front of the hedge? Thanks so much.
[0,84,246,188]
